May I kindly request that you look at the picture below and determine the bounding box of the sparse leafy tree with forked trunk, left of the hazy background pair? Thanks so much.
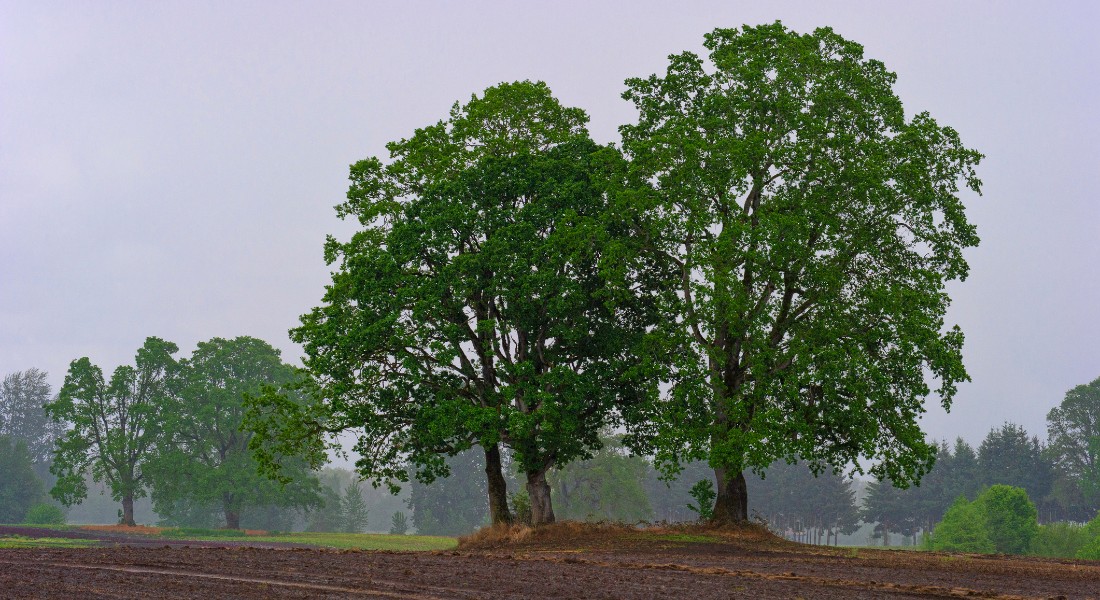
[45,337,178,525]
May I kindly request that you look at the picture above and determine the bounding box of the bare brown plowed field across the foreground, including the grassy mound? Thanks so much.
[0,525,1100,600]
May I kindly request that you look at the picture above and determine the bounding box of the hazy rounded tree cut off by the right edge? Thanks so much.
[1046,378,1100,512]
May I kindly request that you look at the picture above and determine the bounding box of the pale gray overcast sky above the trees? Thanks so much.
[0,0,1100,444]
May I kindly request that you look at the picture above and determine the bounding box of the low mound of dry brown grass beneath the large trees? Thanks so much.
[459,521,802,552]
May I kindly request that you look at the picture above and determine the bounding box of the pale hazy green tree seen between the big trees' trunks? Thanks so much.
[549,437,653,523]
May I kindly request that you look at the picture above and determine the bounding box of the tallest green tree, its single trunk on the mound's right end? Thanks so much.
[622,23,981,522]
